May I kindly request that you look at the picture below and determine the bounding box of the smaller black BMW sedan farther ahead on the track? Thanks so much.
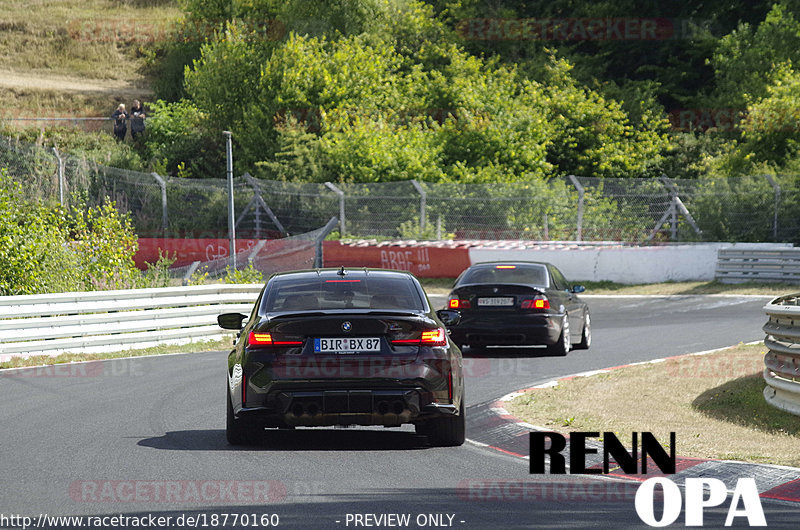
[448,261,592,355]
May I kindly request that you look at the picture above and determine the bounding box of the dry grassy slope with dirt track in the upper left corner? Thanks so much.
[0,0,181,116]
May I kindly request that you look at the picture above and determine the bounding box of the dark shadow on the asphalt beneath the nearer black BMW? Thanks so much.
[137,428,430,451]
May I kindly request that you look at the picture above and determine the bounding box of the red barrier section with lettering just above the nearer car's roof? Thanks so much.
[323,241,470,278]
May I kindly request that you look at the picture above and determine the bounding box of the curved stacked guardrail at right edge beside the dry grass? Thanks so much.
[763,293,800,416]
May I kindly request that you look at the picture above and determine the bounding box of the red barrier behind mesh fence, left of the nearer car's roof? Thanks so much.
[133,237,258,270]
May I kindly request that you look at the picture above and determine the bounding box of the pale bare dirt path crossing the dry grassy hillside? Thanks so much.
[0,70,152,95]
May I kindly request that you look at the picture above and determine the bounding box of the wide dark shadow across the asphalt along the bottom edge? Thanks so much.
[43,477,797,530]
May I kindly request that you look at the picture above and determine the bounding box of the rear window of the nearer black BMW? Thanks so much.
[262,276,425,313]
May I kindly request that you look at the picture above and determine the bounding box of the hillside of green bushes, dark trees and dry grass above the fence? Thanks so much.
[0,0,800,191]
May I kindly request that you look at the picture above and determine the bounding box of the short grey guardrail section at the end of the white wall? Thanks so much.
[716,248,800,283]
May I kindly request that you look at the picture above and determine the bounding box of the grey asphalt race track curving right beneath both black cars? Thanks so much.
[0,296,800,528]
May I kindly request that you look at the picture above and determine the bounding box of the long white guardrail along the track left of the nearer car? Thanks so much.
[0,284,262,362]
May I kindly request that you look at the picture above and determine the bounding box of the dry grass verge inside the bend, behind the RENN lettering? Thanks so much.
[506,344,800,467]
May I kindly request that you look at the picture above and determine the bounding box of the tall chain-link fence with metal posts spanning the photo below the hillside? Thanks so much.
[0,139,800,243]
